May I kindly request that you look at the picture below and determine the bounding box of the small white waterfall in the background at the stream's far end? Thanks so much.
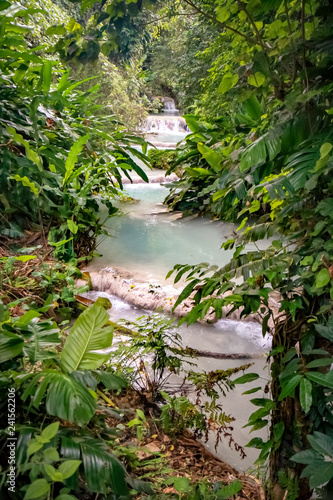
[144,97,189,148]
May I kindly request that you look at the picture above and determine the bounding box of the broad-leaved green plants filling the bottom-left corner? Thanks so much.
[1,304,128,498]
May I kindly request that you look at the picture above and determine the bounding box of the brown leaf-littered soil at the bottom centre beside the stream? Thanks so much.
[99,389,265,500]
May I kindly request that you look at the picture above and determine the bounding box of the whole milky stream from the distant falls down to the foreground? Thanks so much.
[85,102,269,471]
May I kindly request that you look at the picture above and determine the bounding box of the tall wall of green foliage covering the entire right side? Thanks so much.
[153,0,333,498]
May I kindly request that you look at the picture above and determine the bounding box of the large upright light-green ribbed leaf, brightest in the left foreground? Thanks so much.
[61,304,113,372]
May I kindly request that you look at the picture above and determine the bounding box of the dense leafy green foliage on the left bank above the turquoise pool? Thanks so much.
[0,2,147,260]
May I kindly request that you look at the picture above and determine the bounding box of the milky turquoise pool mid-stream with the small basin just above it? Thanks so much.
[96,184,237,279]
